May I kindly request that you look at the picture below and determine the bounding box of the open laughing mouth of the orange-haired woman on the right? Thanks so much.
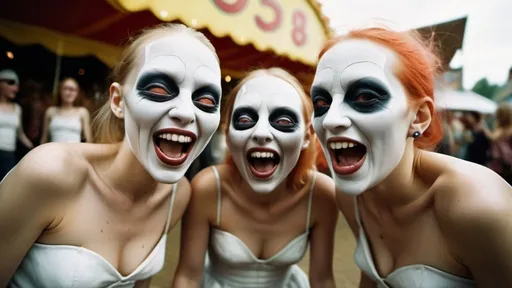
[327,137,366,175]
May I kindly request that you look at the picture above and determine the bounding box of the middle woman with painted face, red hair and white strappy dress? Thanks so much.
[174,68,338,288]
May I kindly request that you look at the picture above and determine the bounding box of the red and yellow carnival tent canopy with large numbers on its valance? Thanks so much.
[0,0,330,86]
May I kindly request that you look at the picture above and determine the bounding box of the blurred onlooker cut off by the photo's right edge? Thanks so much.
[483,103,512,184]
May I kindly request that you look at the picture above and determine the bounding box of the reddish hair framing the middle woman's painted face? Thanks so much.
[221,68,317,189]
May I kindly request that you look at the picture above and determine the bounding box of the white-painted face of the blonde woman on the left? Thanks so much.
[123,32,221,183]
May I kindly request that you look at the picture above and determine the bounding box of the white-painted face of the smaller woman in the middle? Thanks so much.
[227,76,308,193]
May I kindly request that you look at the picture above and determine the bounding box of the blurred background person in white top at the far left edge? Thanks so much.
[0,69,34,181]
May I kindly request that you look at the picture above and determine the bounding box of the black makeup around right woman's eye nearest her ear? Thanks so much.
[345,78,391,113]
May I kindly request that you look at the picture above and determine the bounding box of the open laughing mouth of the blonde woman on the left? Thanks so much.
[153,128,197,166]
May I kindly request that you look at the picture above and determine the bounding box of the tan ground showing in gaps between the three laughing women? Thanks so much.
[151,217,359,288]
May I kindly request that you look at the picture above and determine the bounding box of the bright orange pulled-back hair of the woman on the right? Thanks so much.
[319,28,443,149]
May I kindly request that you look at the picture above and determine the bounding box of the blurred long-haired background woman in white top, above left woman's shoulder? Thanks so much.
[41,77,92,144]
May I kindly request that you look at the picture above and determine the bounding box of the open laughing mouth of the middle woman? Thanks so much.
[247,147,281,178]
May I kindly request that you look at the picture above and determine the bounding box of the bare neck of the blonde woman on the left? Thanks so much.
[105,138,158,202]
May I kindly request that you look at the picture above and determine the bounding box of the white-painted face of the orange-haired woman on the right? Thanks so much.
[311,39,414,195]
